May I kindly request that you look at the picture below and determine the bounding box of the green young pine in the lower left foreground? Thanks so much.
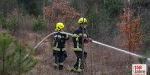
[0,33,38,75]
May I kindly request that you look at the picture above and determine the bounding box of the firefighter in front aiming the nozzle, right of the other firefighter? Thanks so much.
[71,17,92,72]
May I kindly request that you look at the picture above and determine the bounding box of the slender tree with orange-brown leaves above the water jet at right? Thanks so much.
[119,8,143,52]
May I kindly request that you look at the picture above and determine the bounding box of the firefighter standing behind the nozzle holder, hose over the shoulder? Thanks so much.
[53,22,69,70]
